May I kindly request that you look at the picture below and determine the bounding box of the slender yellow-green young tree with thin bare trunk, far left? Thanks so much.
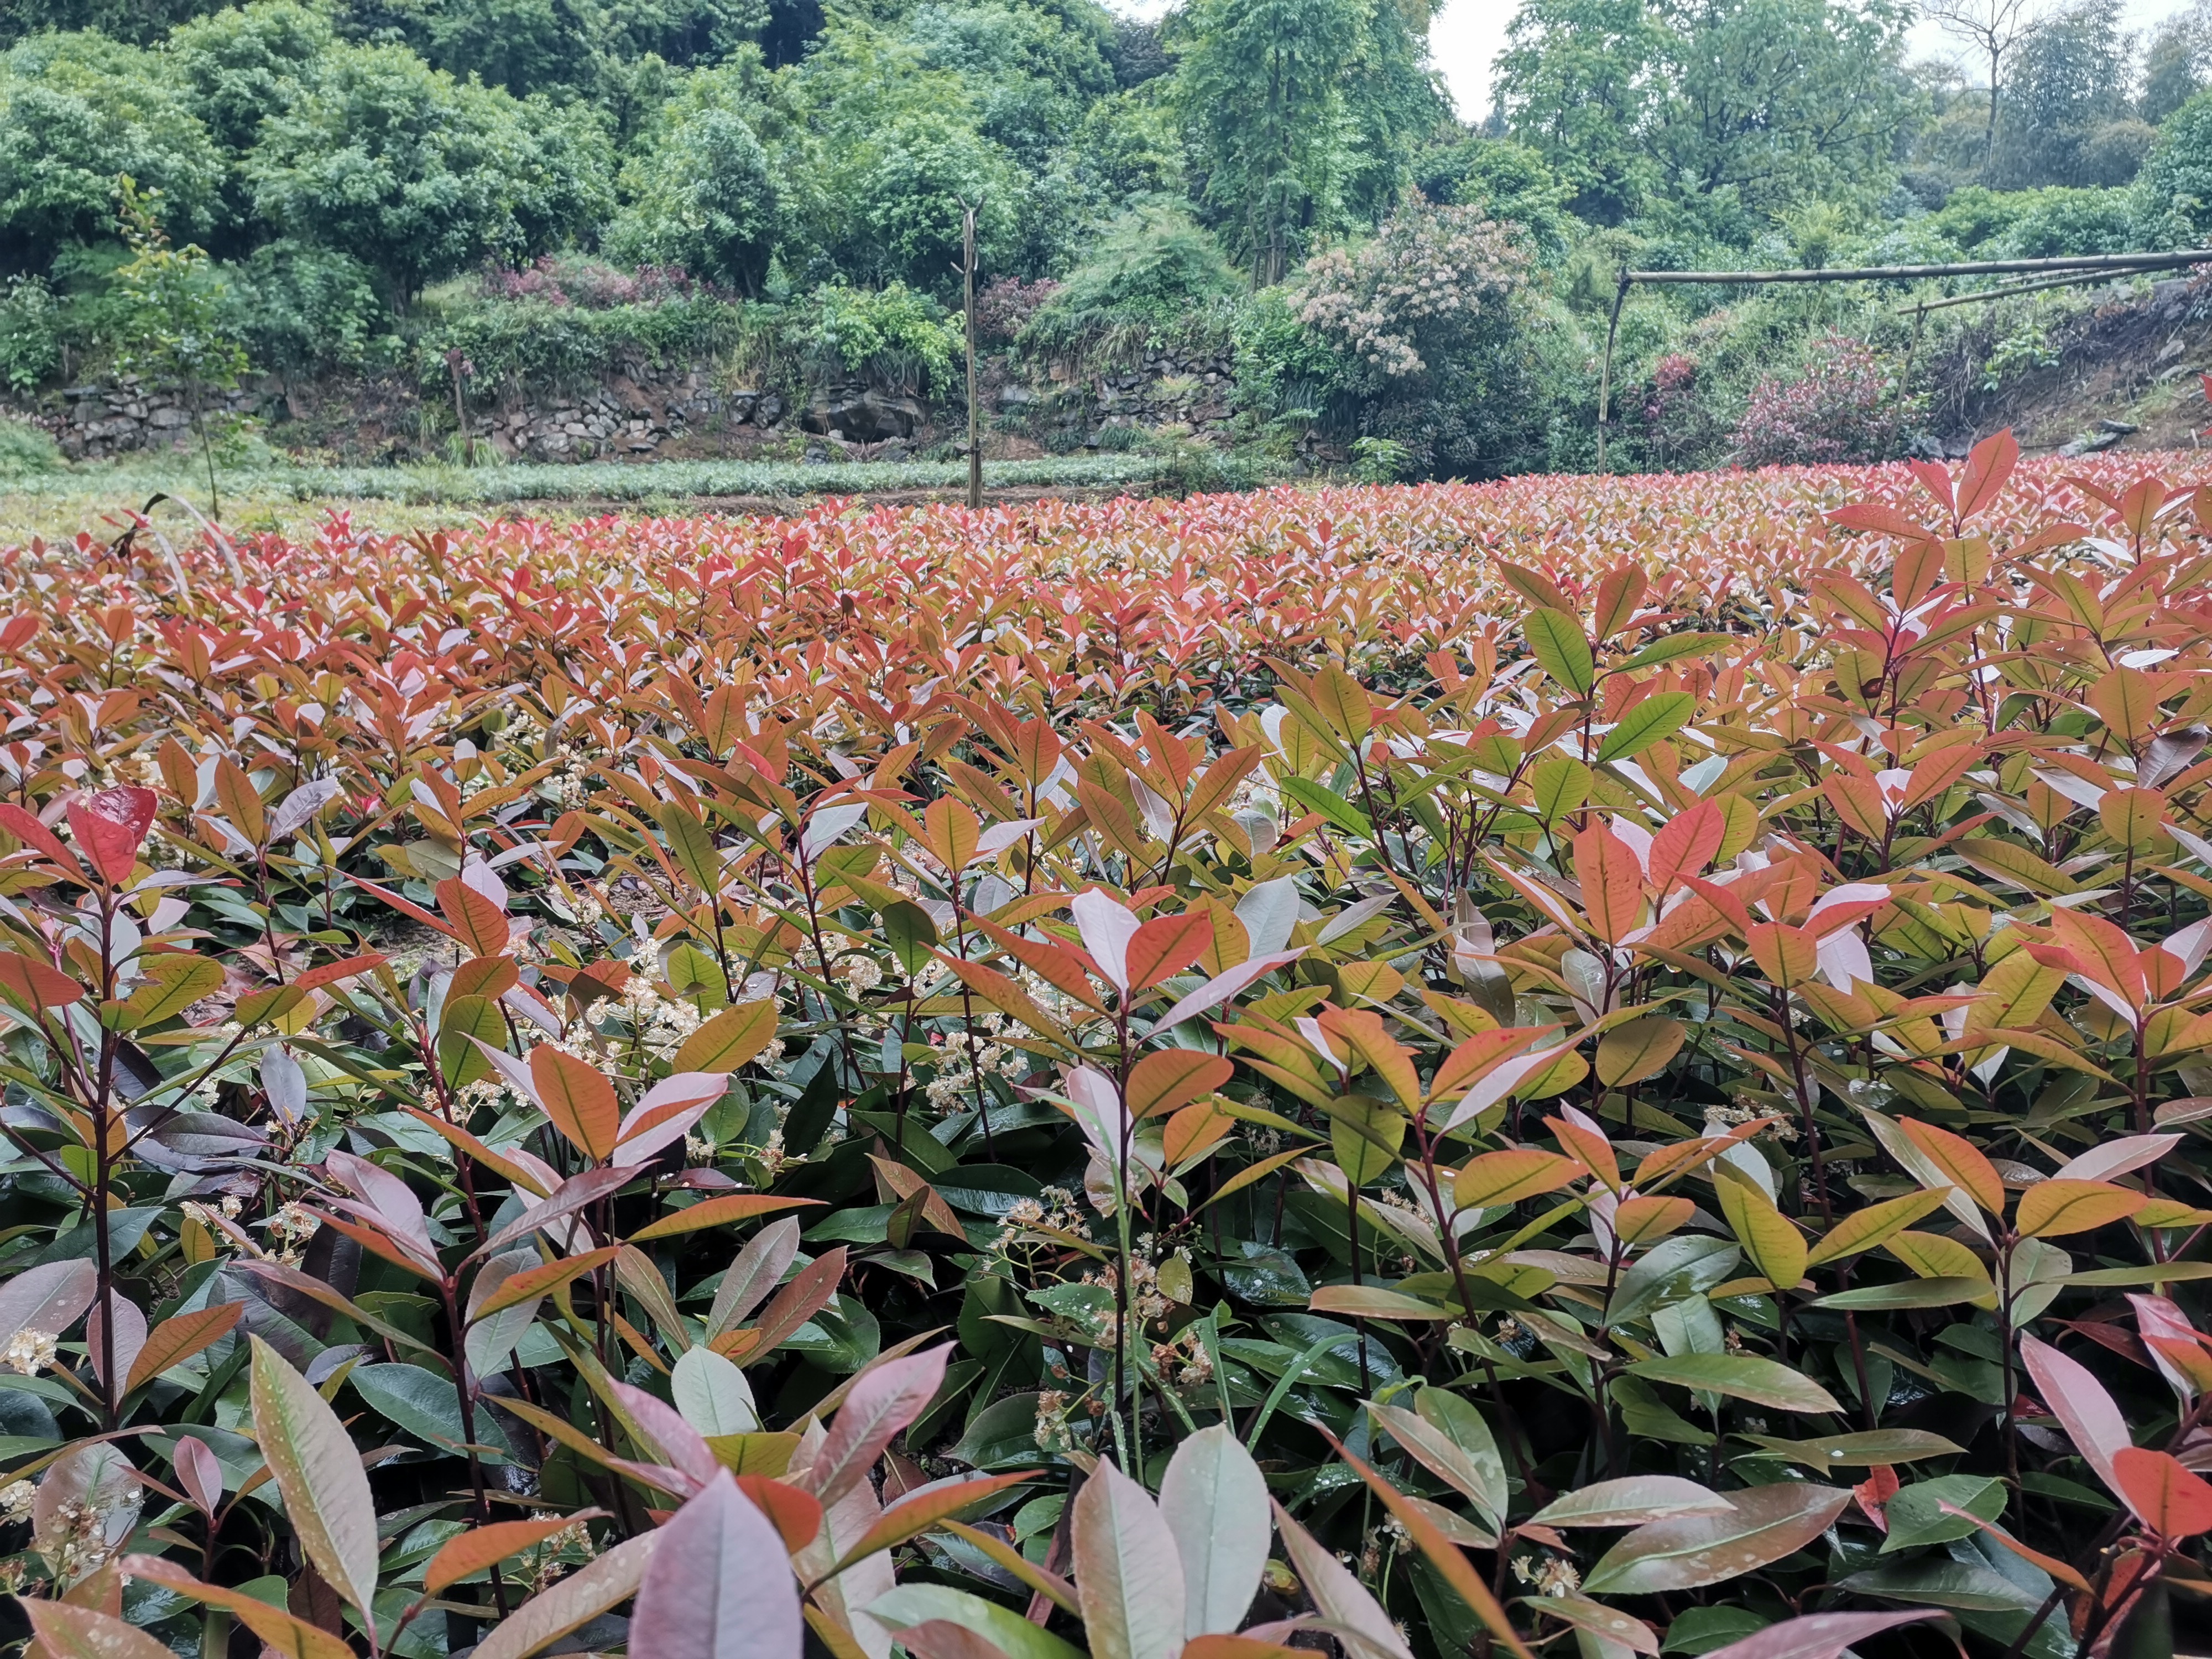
[115,175,246,518]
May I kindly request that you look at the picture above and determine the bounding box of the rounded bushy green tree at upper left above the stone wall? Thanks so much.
[248,46,613,305]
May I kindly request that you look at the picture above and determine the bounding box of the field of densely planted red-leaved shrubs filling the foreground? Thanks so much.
[0,436,2212,1659]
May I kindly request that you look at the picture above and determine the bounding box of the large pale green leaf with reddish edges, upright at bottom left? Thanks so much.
[250,1336,385,1619]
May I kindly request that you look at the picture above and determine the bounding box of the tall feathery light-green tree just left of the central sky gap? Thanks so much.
[1177,0,1369,285]
